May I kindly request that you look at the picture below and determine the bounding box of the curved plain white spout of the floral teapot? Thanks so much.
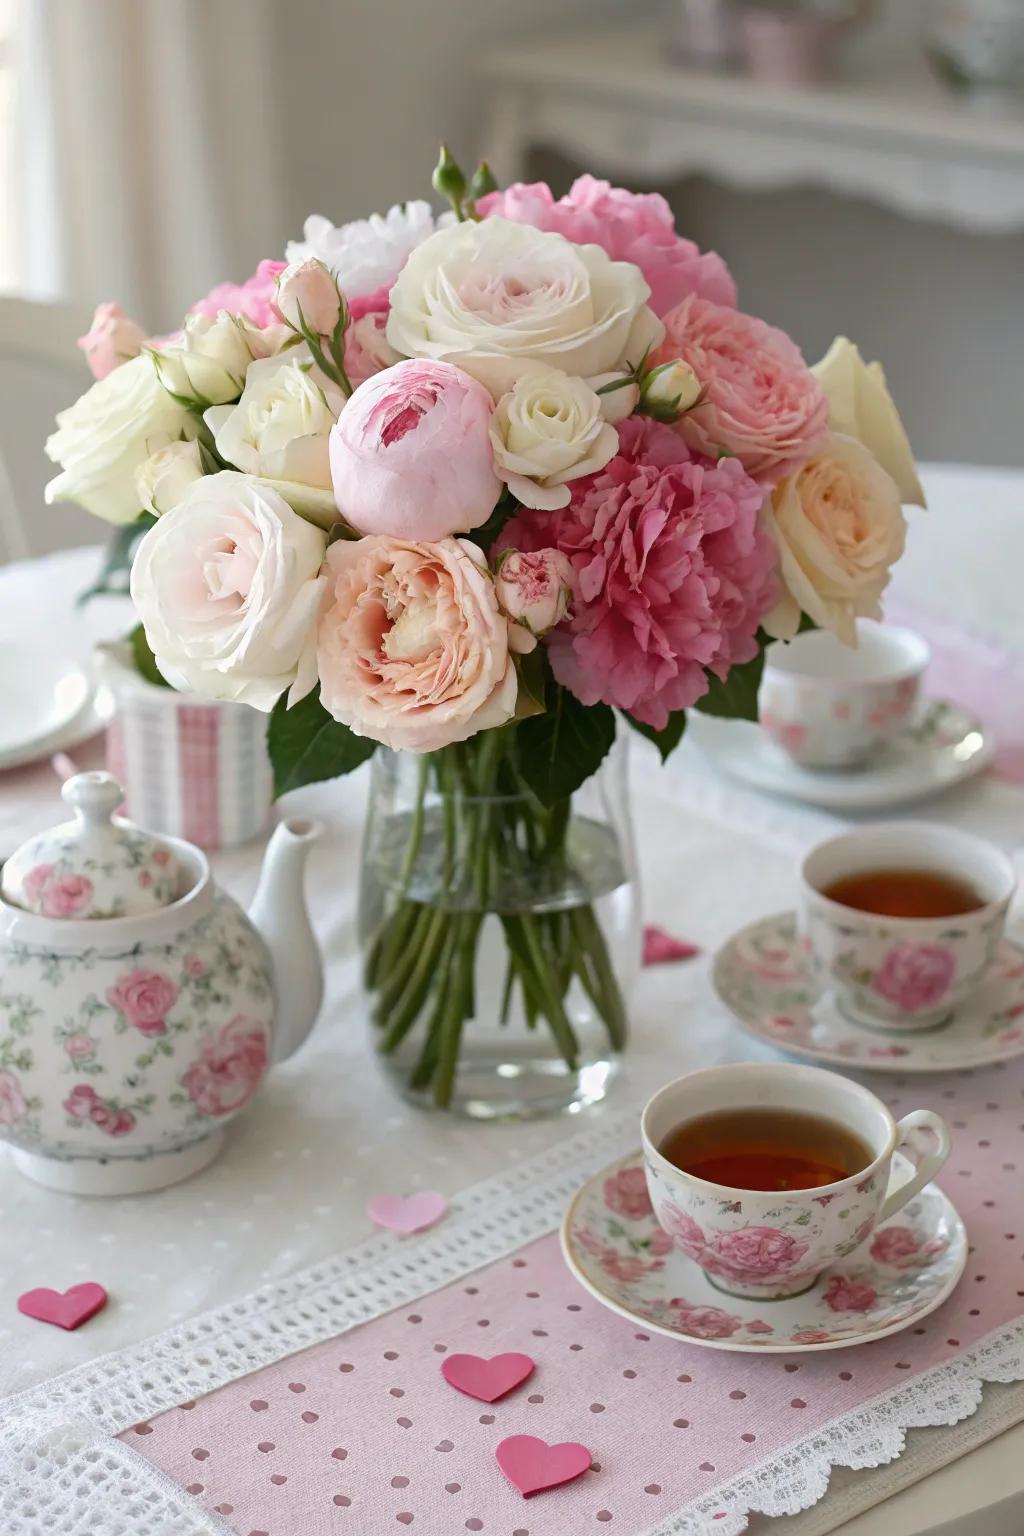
[249,816,324,1061]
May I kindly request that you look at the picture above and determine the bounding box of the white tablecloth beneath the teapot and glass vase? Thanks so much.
[0,467,1024,1530]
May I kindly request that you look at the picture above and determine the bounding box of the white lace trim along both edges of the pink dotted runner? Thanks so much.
[0,1112,1024,1536]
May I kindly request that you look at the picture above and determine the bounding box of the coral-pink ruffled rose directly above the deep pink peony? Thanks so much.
[651,296,829,485]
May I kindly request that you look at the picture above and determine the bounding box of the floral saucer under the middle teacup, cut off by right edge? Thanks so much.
[711,912,1024,1074]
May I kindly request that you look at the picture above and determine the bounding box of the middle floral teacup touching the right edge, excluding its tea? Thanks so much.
[800,822,1016,1031]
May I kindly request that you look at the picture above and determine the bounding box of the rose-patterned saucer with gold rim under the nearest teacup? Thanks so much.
[562,1150,967,1355]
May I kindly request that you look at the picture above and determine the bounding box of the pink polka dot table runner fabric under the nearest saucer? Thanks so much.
[121,1064,1024,1536]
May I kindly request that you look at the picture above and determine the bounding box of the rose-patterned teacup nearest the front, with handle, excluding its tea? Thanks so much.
[642,1061,950,1301]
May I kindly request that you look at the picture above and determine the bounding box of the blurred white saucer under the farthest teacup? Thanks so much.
[689,699,995,811]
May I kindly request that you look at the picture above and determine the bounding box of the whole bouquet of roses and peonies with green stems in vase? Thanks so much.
[46,151,923,1104]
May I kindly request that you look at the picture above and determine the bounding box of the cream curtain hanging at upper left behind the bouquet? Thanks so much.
[18,0,286,332]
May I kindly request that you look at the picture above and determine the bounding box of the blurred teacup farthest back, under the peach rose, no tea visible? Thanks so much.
[758,619,929,768]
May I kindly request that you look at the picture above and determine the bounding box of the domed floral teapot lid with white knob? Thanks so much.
[0,773,183,922]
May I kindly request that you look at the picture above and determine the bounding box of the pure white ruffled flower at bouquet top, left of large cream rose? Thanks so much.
[284,200,451,300]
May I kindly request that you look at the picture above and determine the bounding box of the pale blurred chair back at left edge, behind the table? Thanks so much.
[0,298,103,564]
